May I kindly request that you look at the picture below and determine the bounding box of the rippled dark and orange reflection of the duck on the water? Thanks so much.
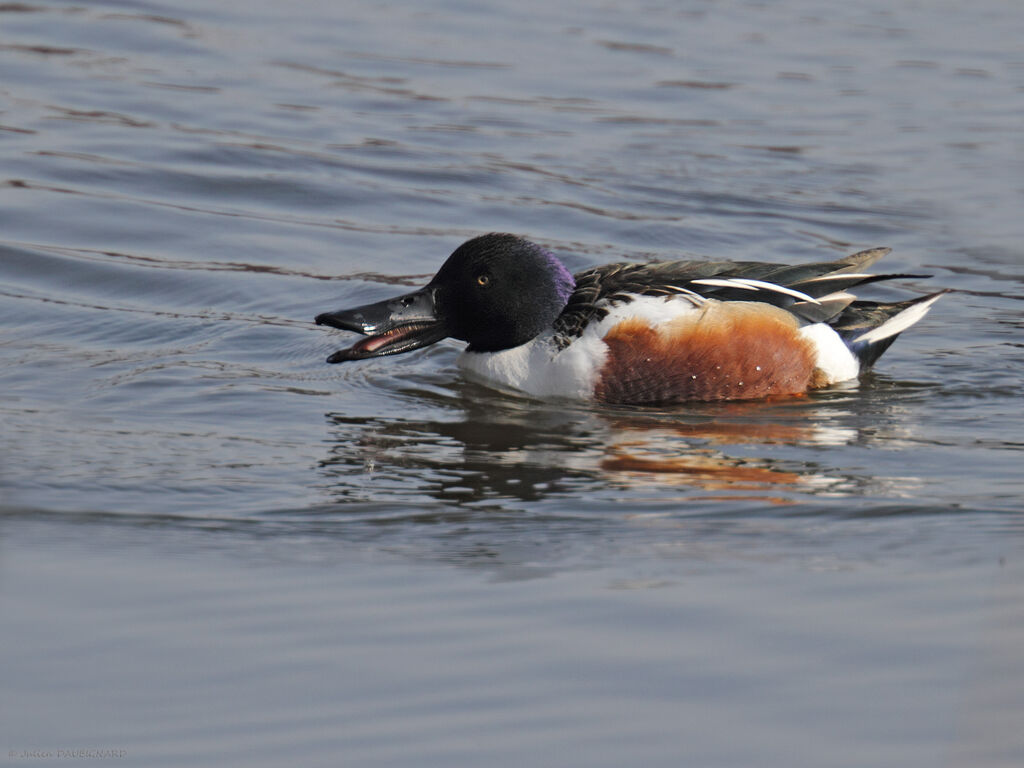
[321,393,910,506]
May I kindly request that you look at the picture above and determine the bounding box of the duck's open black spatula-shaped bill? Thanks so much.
[316,288,449,362]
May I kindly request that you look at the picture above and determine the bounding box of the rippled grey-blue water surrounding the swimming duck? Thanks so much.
[0,0,1024,766]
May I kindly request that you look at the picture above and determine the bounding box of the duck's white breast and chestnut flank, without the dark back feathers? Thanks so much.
[459,296,859,403]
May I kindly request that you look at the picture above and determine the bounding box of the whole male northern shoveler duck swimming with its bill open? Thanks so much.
[316,233,944,404]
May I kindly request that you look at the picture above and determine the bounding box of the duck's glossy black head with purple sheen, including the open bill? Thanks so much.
[316,233,575,362]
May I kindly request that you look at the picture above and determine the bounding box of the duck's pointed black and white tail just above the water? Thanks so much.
[828,289,949,369]
